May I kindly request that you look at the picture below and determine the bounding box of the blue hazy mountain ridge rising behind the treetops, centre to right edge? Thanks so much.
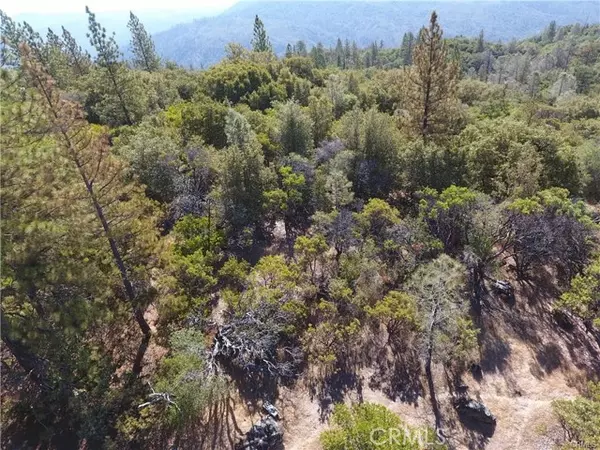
[154,0,600,67]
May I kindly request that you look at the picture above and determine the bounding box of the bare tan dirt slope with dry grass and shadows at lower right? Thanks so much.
[270,268,600,450]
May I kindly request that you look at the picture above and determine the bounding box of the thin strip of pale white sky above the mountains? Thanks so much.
[2,0,236,15]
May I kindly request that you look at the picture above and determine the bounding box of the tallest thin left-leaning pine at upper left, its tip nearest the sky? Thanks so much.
[85,6,134,125]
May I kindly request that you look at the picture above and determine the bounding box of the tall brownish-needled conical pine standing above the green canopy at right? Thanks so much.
[403,11,459,141]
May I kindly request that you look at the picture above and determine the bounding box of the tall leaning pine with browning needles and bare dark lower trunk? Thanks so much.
[22,48,156,375]
